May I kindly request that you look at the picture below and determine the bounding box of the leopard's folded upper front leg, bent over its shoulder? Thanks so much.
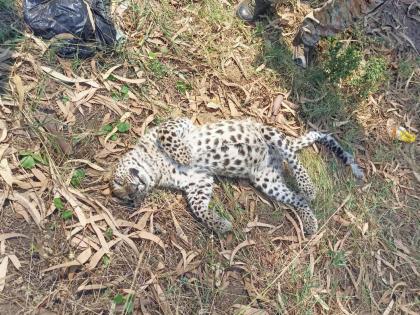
[156,118,193,165]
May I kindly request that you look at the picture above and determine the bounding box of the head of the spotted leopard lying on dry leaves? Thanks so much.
[111,156,152,206]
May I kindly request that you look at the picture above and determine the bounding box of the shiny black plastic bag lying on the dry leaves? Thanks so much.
[23,0,117,58]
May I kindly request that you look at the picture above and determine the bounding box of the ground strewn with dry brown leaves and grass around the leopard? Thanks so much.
[0,0,420,314]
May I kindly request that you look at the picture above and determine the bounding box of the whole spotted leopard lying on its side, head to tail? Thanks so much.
[111,119,363,234]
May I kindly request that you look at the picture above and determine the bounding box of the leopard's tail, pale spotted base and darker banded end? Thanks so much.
[289,131,365,179]
